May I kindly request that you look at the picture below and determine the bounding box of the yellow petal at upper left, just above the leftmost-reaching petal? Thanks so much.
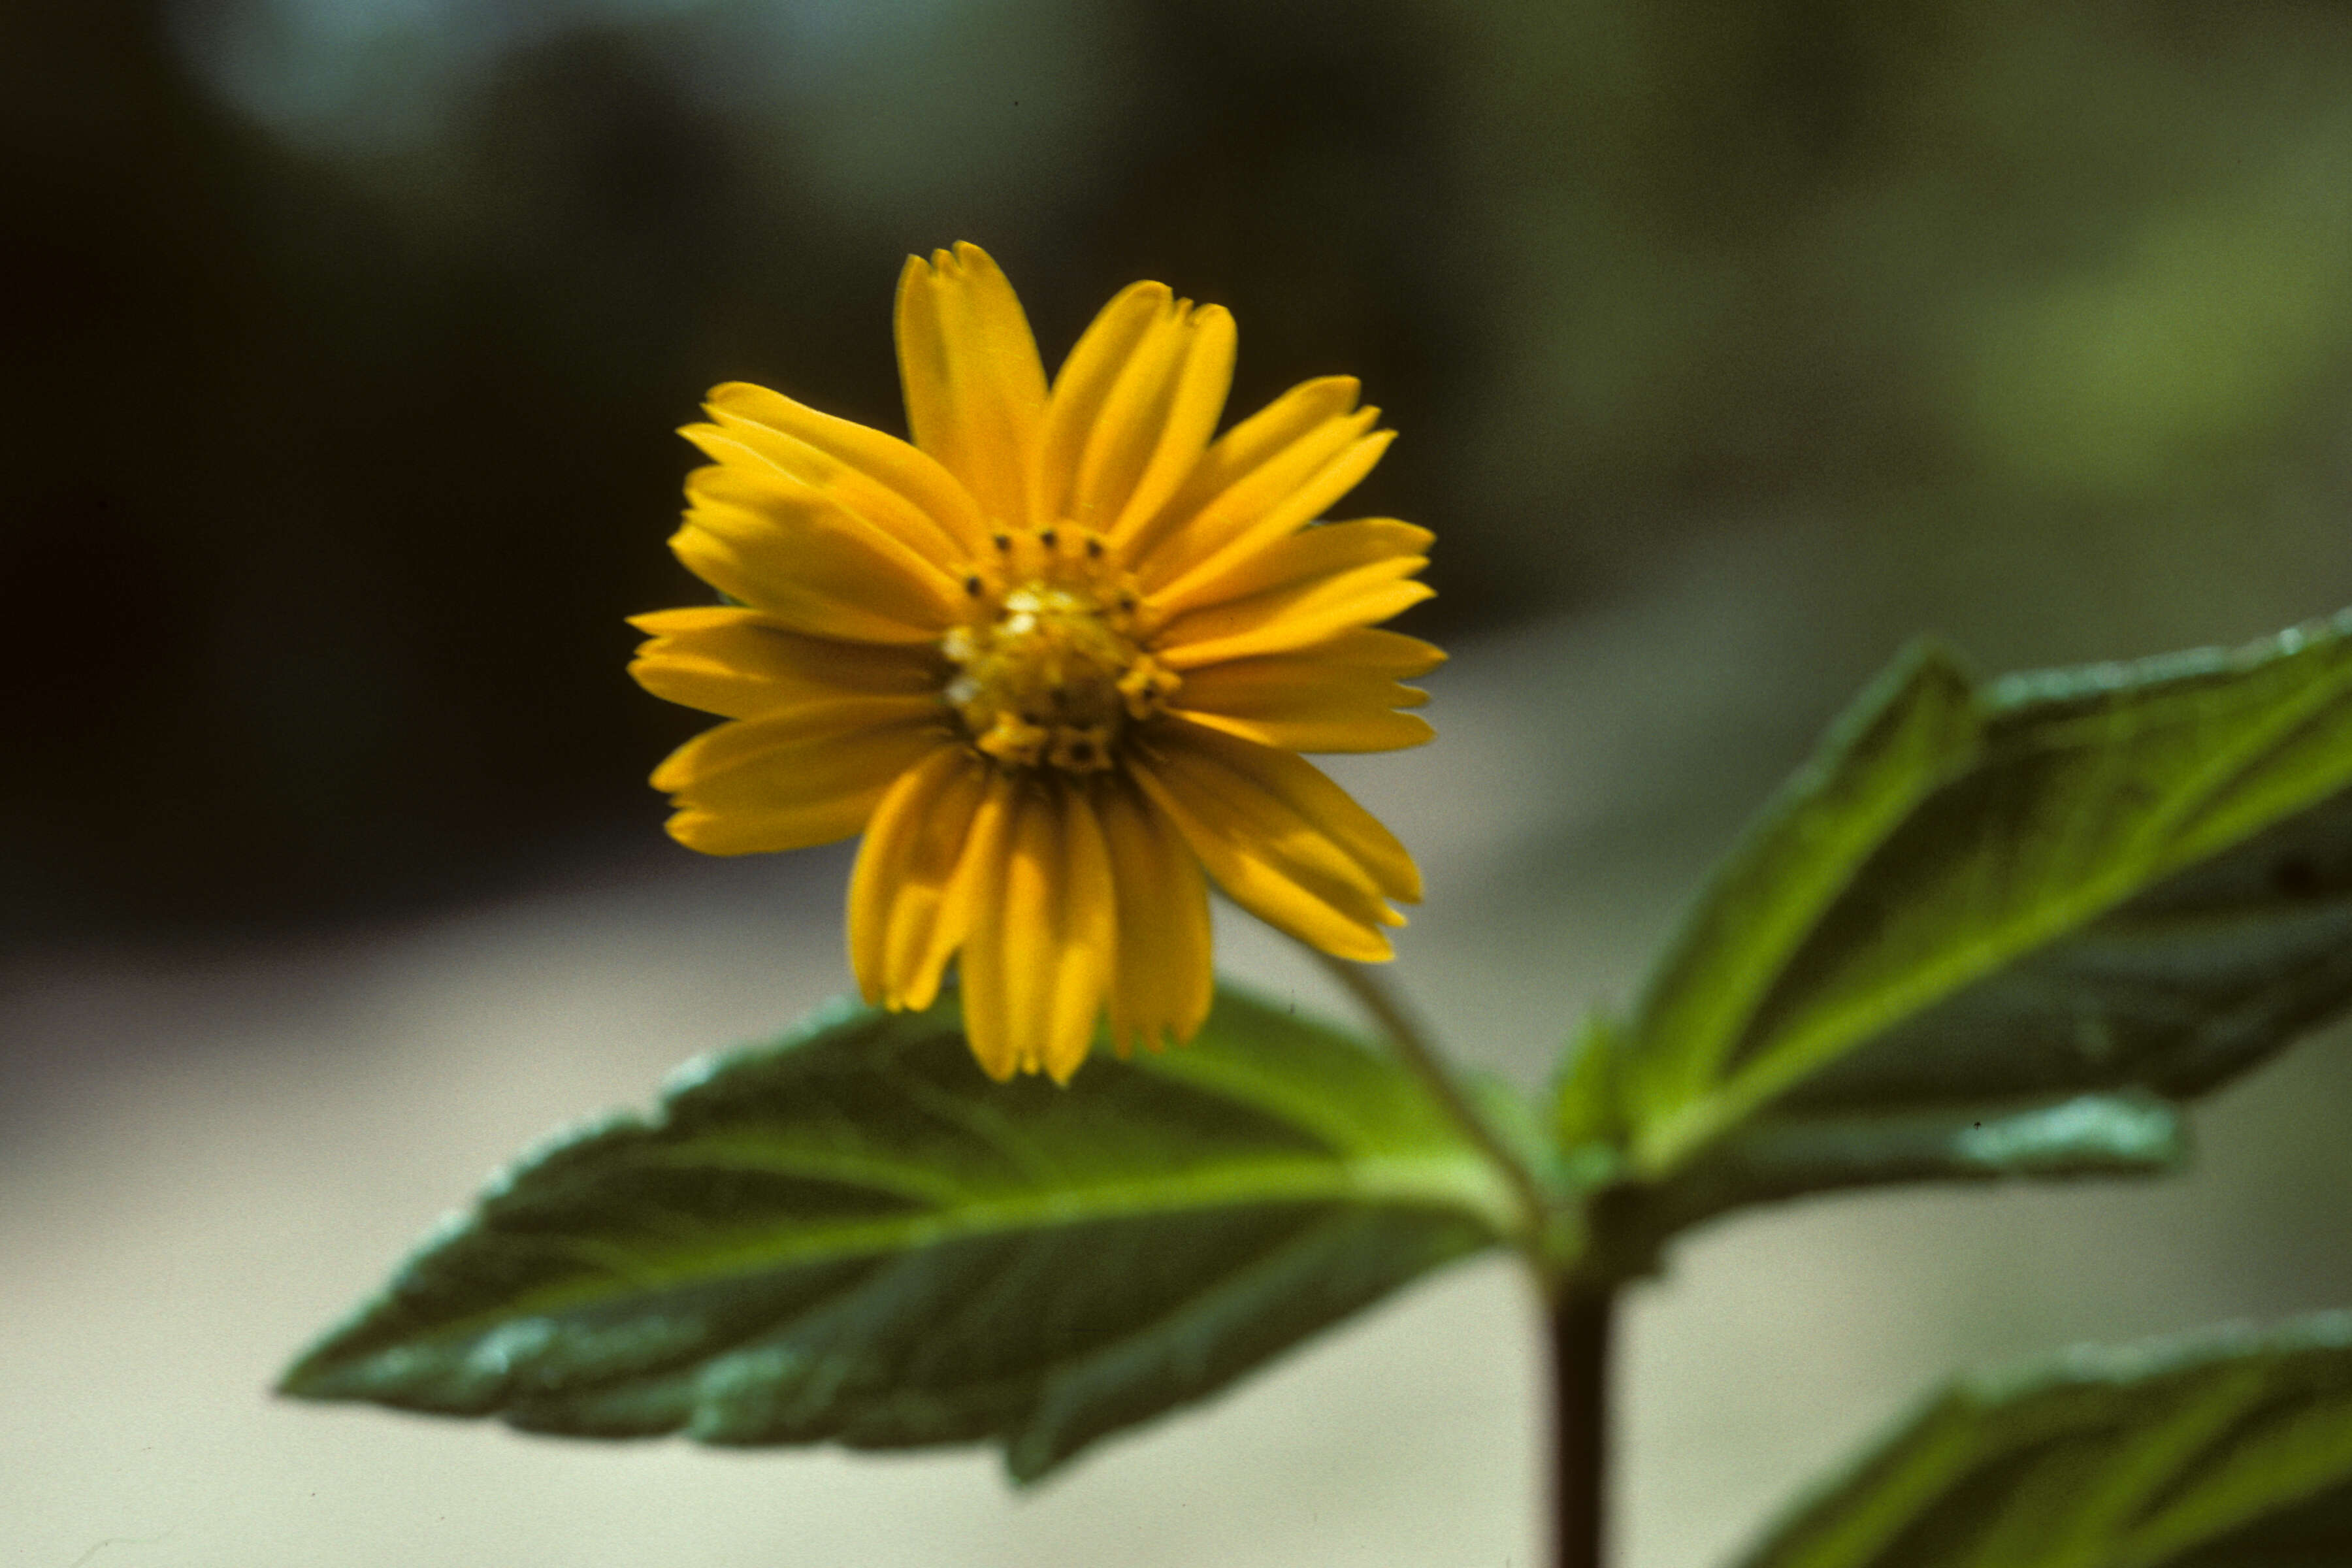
[670,463,962,642]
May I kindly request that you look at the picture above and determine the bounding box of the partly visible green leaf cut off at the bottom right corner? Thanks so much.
[1745,1312,2352,1568]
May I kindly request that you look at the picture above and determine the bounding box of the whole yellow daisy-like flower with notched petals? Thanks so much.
[630,244,1444,1081]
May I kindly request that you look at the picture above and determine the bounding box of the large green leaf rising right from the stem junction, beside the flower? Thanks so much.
[1618,618,2352,1183]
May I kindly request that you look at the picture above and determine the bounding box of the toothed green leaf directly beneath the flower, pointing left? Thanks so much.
[282,992,1517,1481]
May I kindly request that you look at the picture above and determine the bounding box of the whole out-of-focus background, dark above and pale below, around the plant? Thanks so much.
[14,0,2352,1568]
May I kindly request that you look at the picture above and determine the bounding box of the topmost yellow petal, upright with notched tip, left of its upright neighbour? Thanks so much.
[898,244,1044,527]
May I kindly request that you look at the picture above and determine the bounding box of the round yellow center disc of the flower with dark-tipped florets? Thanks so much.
[941,524,1176,774]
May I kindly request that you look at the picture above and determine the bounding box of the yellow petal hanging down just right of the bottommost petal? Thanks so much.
[1098,778,1216,1056]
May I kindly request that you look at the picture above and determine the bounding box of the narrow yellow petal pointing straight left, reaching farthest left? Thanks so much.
[628,604,945,719]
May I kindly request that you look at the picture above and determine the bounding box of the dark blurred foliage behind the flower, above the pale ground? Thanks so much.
[14,0,2352,940]
